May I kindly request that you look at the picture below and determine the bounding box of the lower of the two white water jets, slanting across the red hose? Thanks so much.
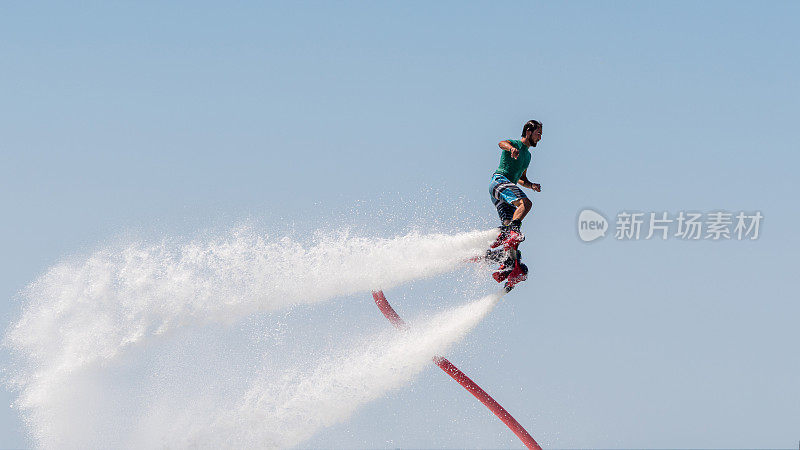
[135,293,502,448]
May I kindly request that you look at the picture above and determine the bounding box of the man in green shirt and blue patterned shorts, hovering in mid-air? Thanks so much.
[489,120,542,248]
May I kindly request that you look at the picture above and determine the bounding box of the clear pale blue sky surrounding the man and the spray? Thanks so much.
[0,1,800,448]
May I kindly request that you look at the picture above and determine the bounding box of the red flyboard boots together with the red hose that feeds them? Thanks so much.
[372,234,542,450]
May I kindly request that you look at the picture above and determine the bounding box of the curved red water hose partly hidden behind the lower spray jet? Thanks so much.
[372,291,542,450]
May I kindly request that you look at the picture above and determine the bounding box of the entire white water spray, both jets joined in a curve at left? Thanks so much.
[6,230,494,447]
